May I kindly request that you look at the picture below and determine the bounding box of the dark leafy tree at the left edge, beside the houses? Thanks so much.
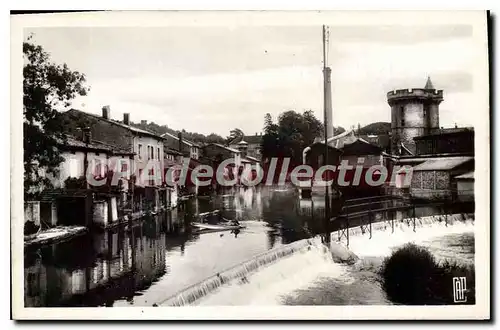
[23,37,89,197]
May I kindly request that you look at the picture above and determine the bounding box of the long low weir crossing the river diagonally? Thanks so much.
[158,214,474,306]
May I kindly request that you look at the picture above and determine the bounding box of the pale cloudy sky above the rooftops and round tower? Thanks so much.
[25,24,478,137]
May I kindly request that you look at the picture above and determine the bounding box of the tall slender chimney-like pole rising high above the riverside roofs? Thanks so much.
[323,25,330,246]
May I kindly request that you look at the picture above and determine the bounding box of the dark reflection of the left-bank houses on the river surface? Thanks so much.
[25,219,172,307]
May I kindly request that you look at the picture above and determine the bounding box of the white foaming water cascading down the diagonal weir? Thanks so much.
[156,214,474,306]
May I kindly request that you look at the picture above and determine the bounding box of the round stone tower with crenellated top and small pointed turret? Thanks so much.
[387,77,443,155]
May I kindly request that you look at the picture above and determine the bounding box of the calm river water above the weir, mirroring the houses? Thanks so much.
[24,187,468,307]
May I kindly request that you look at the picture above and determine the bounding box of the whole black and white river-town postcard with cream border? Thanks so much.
[10,11,490,320]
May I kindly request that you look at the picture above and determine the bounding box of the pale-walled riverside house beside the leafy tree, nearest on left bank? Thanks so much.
[31,130,133,227]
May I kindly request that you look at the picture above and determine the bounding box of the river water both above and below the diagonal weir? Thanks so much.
[24,188,473,307]
